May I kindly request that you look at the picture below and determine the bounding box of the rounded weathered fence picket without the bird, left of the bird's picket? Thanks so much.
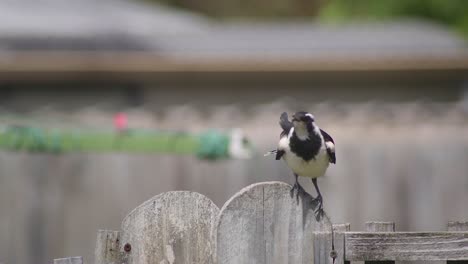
[120,191,219,264]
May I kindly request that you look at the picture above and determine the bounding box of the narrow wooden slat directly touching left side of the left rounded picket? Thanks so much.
[94,230,120,264]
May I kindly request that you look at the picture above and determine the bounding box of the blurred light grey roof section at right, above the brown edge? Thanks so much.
[155,21,468,59]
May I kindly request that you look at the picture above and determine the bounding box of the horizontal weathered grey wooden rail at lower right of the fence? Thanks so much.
[345,232,468,261]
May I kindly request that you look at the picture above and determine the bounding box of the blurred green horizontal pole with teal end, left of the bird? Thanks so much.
[0,126,234,160]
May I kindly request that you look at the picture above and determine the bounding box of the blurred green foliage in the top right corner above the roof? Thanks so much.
[319,0,468,36]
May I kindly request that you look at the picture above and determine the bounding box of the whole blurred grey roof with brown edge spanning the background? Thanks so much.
[0,0,468,78]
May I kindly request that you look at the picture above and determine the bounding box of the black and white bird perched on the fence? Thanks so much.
[270,112,336,217]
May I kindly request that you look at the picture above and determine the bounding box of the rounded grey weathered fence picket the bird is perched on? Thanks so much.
[216,182,315,264]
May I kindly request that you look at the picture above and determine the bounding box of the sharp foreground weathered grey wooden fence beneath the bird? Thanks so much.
[54,182,468,264]
